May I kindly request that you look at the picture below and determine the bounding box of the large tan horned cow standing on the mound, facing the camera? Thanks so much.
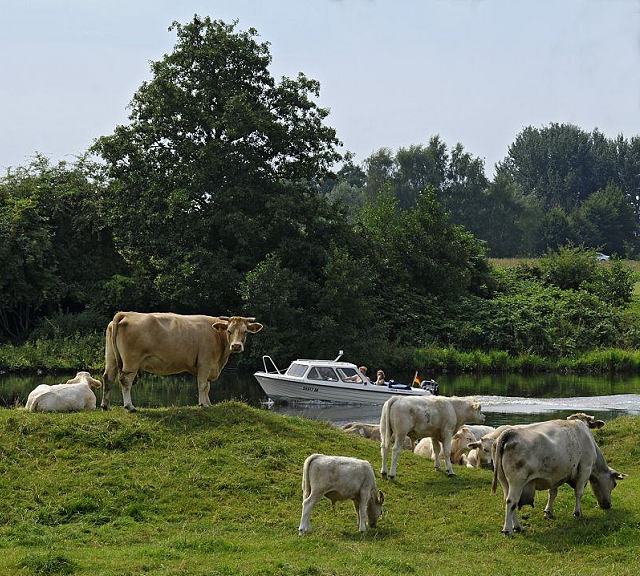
[102,312,262,412]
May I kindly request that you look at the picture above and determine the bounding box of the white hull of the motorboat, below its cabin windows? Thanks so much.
[254,372,431,404]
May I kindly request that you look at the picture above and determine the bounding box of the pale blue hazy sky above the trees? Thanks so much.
[0,0,640,175]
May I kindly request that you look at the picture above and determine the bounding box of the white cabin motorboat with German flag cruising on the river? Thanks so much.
[254,352,437,404]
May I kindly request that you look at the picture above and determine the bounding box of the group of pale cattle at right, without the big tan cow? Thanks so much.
[316,396,625,535]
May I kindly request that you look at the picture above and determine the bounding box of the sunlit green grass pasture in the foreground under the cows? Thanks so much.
[0,403,640,576]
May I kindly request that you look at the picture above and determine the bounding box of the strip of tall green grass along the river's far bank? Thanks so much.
[0,333,640,377]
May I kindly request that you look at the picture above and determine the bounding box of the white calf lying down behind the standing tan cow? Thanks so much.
[25,372,101,412]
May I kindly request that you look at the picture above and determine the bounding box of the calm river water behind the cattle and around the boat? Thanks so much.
[0,368,640,425]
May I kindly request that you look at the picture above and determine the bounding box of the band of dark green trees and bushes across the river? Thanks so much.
[0,16,640,365]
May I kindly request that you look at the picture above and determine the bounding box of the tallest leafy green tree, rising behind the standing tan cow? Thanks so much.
[94,16,339,312]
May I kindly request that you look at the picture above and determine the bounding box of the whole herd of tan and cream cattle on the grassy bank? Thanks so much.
[17,312,624,534]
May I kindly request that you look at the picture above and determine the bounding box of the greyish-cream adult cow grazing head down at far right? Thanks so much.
[492,419,624,534]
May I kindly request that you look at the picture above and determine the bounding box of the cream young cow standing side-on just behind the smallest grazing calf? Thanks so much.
[380,396,484,478]
